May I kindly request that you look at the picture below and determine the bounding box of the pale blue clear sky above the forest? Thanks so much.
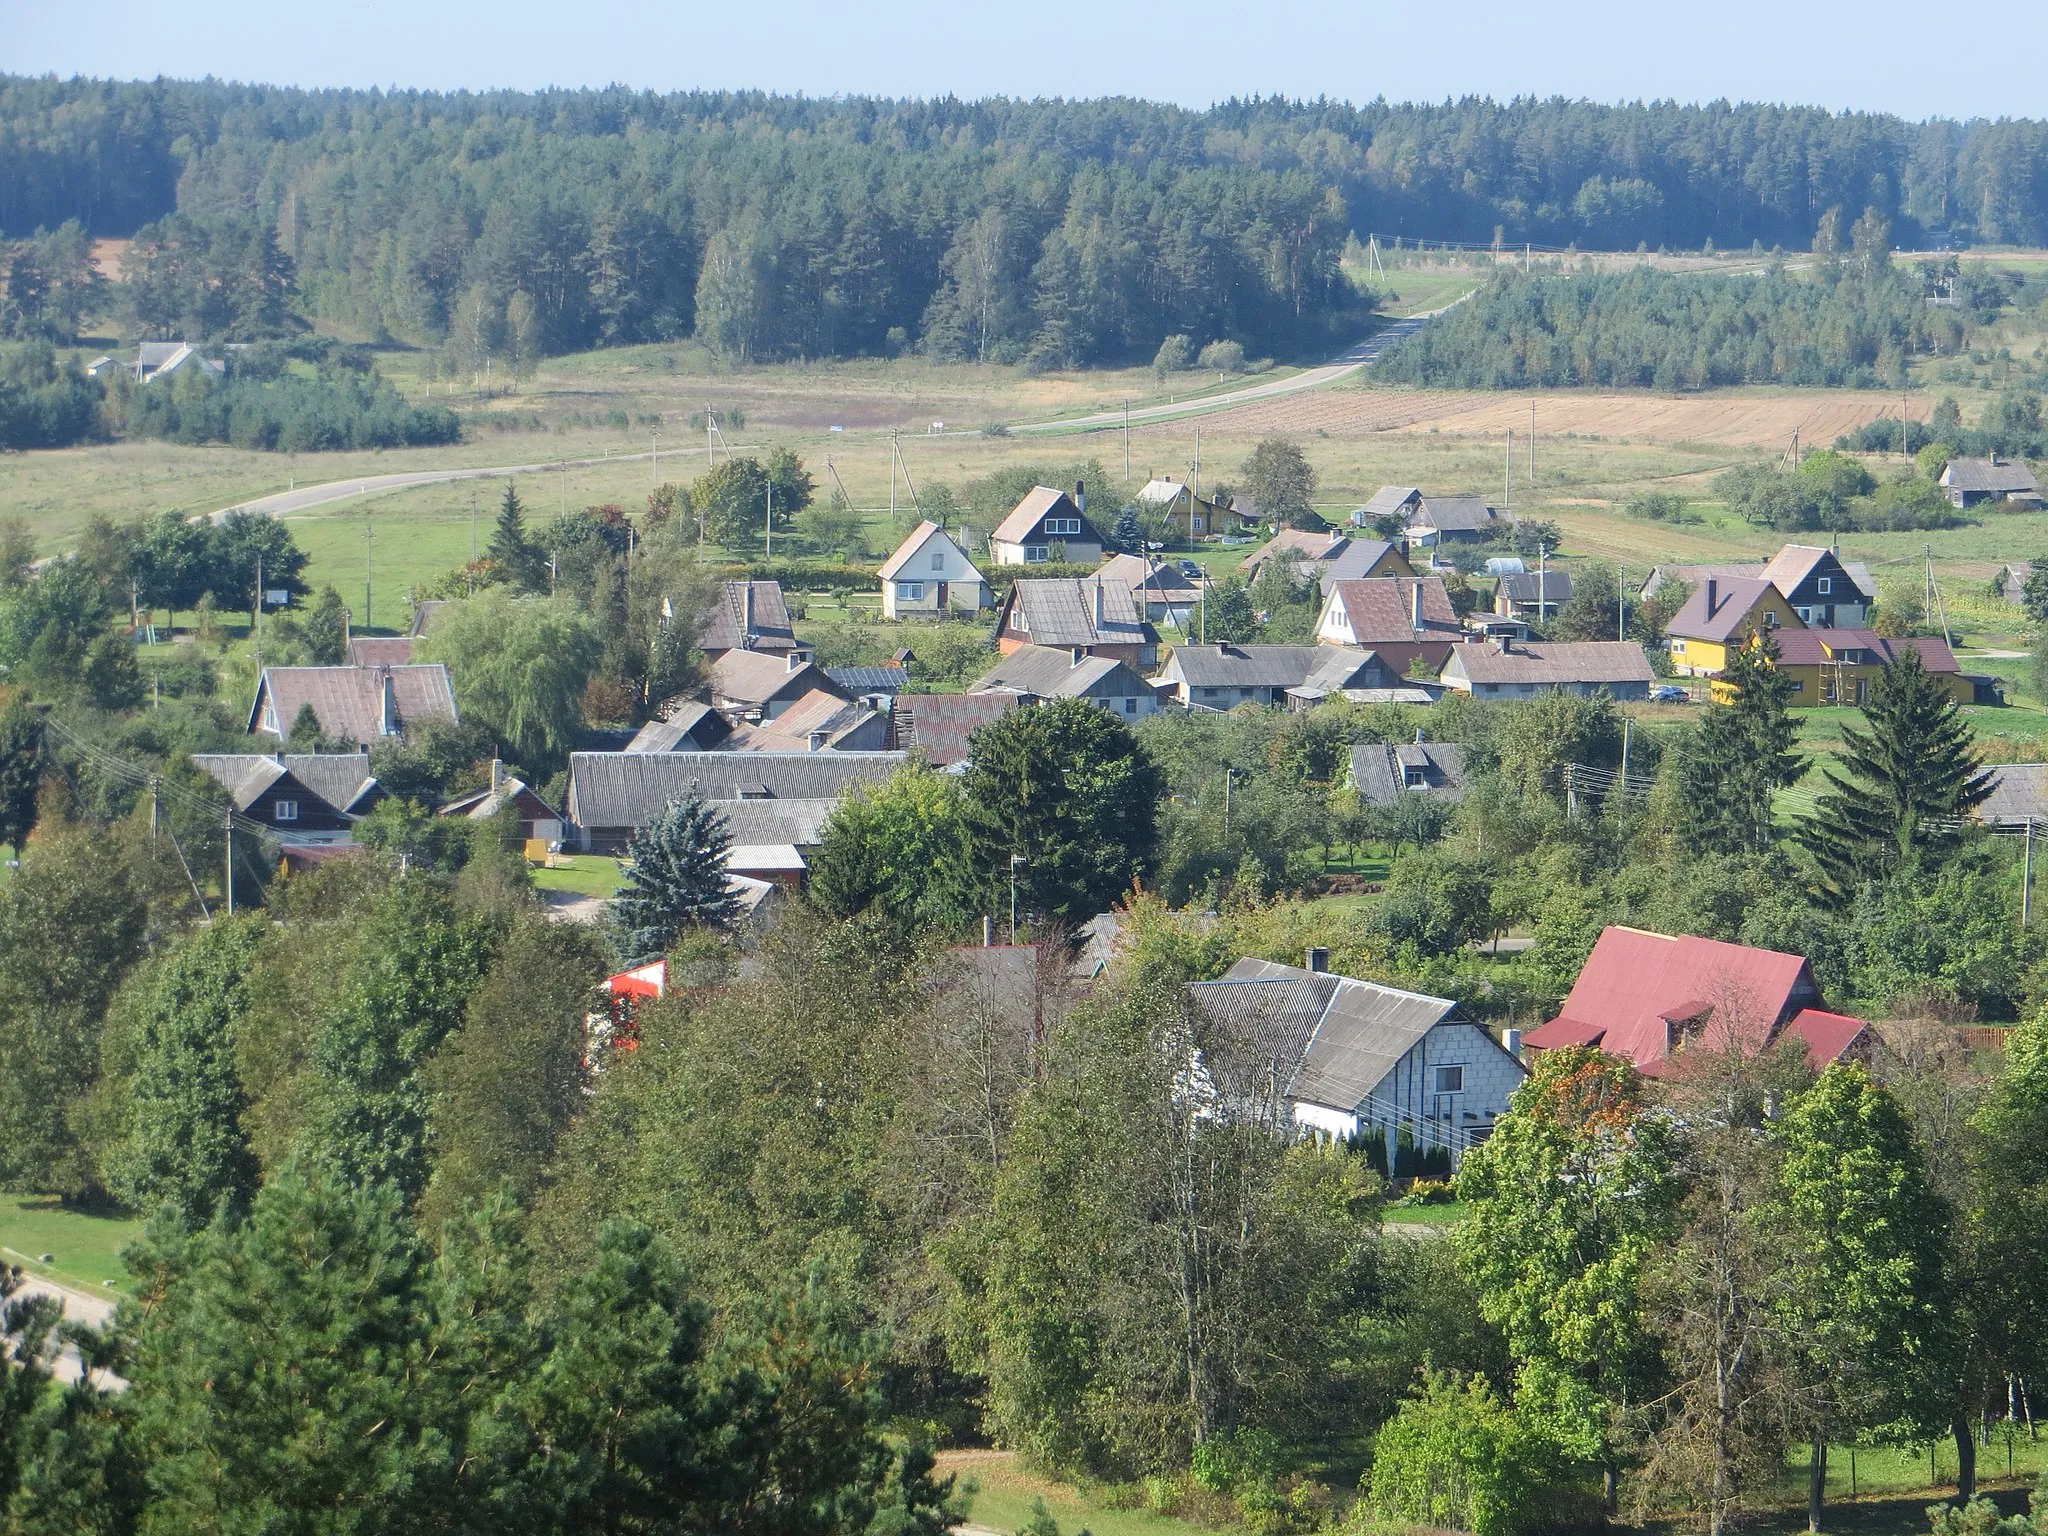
[12,0,2048,119]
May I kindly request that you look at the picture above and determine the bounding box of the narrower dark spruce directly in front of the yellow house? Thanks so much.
[1679,629,1806,854]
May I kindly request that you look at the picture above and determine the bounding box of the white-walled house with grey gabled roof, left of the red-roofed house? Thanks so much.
[1188,948,1528,1161]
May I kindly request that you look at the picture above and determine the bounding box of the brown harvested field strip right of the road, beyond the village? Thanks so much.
[1204,389,1933,449]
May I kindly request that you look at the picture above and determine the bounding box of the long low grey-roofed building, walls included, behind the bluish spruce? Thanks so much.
[563,752,903,854]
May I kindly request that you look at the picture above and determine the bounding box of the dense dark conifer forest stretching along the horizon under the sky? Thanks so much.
[0,76,2048,373]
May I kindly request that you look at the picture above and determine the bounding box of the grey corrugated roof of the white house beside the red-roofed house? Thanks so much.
[1188,958,1458,1112]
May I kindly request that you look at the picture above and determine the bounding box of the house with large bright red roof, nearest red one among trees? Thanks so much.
[1522,926,1870,1077]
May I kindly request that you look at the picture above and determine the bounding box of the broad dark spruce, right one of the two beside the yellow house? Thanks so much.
[1800,647,1991,903]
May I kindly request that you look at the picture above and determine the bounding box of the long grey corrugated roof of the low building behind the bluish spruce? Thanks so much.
[567,752,903,842]
